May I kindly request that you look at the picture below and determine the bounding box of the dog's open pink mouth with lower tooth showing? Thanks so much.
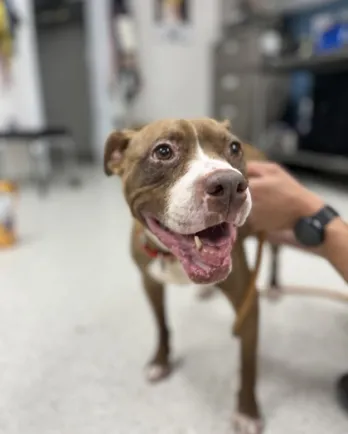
[146,217,237,283]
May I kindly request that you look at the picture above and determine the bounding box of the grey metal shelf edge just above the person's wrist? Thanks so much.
[268,150,348,176]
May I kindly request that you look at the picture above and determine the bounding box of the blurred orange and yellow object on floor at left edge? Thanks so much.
[0,180,17,248]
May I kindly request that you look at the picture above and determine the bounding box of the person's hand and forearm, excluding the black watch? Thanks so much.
[248,162,348,282]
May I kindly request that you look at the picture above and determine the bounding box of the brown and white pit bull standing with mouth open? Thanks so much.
[104,118,263,434]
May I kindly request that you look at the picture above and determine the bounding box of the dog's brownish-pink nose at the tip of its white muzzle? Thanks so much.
[204,170,248,206]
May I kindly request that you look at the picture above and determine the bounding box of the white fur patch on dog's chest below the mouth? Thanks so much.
[148,257,192,285]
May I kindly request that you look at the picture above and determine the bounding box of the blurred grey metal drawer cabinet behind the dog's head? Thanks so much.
[212,25,286,143]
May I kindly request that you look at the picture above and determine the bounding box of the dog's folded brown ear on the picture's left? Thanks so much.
[104,130,135,176]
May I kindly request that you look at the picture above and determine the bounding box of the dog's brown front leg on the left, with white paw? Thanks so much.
[143,274,170,382]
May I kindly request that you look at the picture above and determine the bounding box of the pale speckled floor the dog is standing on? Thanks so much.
[0,172,348,434]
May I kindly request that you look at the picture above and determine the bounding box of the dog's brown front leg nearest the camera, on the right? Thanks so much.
[219,243,262,434]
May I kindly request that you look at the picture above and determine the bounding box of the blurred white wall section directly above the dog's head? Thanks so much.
[132,0,220,122]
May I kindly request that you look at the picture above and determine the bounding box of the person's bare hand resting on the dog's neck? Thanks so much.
[247,161,324,232]
